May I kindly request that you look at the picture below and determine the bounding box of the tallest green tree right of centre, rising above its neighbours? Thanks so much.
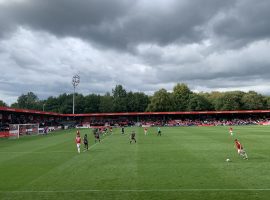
[173,83,192,111]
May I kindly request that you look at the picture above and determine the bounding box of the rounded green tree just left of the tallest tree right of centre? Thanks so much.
[147,89,174,112]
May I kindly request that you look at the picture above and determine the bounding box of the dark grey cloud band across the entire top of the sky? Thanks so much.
[0,0,270,50]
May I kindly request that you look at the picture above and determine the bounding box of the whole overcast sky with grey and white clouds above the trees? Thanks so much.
[0,0,270,104]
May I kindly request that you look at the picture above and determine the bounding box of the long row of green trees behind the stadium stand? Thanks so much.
[3,83,270,114]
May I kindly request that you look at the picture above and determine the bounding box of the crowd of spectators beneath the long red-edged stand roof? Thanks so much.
[0,113,270,131]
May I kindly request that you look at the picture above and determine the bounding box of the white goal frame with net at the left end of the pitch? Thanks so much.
[9,124,39,139]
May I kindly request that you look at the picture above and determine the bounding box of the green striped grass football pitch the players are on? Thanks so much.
[0,126,270,200]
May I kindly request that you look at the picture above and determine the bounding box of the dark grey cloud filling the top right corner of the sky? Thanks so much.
[213,0,270,47]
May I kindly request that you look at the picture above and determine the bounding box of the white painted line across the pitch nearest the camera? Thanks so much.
[0,188,270,193]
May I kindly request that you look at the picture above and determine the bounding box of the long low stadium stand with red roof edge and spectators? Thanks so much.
[0,107,270,137]
